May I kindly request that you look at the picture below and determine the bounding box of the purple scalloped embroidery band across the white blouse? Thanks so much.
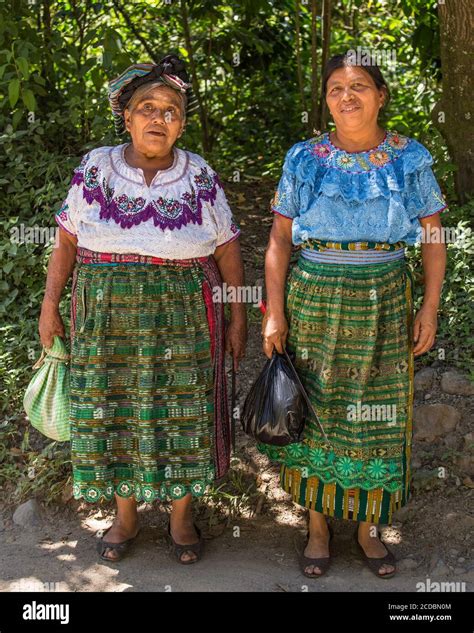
[71,156,222,230]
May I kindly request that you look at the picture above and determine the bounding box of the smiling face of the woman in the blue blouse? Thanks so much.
[326,66,386,131]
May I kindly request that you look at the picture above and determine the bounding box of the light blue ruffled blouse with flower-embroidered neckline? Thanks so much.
[272,131,446,245]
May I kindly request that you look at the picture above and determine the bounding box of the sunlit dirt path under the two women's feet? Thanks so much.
[0,464,474,592]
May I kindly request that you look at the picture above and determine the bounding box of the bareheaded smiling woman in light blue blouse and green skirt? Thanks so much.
[259,55,446,578]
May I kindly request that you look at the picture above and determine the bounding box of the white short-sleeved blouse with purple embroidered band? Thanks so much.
[55,143,240,259]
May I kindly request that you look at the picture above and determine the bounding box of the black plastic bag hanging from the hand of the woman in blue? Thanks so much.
[241,350,327,446]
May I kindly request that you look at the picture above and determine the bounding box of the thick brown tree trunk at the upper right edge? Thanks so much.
[431,0,474,204]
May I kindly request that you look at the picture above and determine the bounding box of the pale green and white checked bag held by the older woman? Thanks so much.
[23,336,70,442]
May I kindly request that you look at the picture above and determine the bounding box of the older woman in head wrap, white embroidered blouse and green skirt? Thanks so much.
[39,56,246,564]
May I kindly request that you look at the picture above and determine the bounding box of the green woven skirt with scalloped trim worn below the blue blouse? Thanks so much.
[258,257,413,523]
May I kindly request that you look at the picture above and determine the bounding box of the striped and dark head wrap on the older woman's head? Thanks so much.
[109,55,198,135]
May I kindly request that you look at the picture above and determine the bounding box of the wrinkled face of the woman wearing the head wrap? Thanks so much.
[124,86,185,158]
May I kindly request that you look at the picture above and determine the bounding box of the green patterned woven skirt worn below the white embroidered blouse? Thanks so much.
[70,252,228,502]
